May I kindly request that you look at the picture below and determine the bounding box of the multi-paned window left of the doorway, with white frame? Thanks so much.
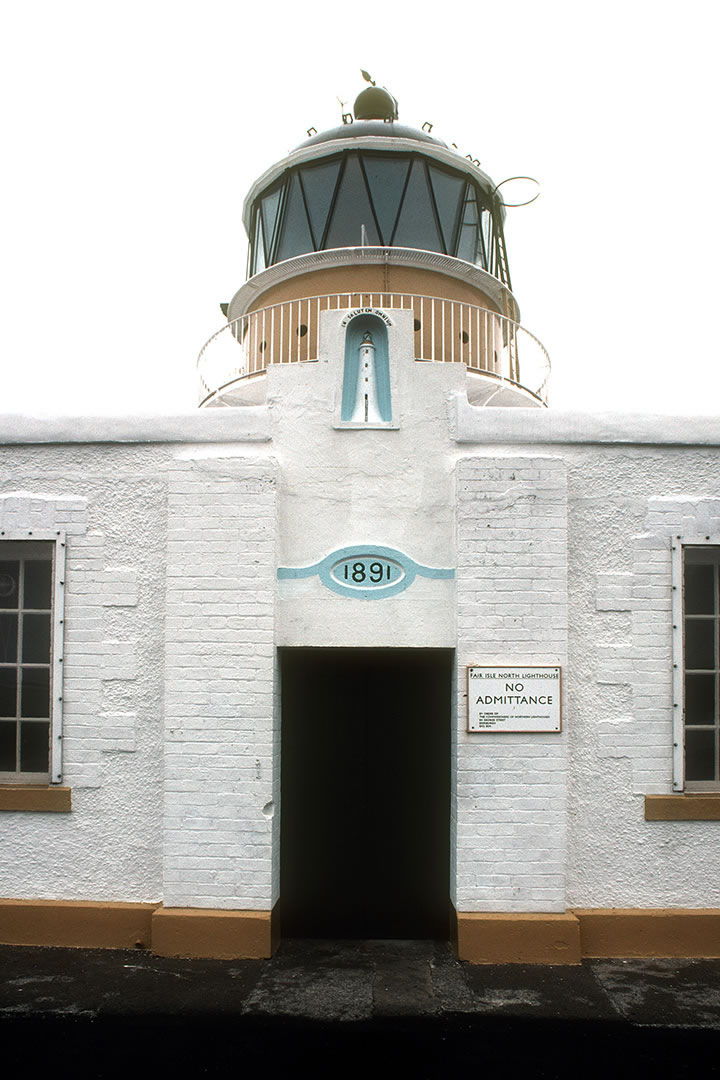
[0,534,65,784]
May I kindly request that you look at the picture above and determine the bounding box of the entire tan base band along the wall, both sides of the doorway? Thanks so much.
[0,900,720,964]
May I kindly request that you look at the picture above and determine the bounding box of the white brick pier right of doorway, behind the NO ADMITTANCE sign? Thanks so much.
[456,456,568,912]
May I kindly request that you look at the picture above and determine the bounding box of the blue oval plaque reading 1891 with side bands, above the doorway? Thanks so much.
[277,544,454,599]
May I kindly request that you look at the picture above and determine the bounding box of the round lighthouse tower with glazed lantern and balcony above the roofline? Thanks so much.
[199,85,549,408]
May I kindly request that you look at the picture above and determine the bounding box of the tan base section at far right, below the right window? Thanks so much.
[573,907,720,959]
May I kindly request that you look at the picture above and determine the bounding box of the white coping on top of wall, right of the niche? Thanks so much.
[450,393,720,446]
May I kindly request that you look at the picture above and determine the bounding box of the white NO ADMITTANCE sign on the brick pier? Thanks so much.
[467,665,561,732]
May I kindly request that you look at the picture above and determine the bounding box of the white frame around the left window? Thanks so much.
[0,529,66,786]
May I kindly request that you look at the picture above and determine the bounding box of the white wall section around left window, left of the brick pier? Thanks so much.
[0,455,165,901]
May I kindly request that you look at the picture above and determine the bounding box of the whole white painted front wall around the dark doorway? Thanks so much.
[0,360,720,910]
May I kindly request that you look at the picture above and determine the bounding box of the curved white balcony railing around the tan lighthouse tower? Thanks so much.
[198,293,551,405]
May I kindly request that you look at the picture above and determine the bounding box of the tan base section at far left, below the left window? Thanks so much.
[0,900,157,948]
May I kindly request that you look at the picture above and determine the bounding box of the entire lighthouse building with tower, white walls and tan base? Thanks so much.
[5,76,720,963]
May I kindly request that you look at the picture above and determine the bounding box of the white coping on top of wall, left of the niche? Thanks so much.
[0,405,271,446]
